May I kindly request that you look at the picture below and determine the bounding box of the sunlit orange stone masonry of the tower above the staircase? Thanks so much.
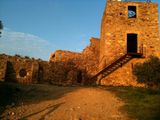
[100,2,160,68]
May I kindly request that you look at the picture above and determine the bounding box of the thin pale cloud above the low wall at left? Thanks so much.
[0,28,56,60]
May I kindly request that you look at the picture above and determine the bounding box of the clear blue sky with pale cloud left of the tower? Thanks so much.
[0,0,160,60]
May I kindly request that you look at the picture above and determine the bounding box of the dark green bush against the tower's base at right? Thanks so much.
[133,56,160,86]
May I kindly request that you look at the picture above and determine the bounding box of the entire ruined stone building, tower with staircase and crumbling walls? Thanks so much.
[0,0,160,86]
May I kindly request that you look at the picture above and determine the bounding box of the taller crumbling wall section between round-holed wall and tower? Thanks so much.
[50,38,99,84]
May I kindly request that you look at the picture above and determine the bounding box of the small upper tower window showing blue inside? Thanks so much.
[128,6,137,18]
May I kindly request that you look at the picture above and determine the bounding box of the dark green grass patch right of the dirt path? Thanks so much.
[103,87,160,120]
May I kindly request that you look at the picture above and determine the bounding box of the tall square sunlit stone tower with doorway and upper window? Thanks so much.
[97,0,160,85]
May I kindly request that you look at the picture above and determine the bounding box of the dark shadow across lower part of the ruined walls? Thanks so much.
[2,56,95,86]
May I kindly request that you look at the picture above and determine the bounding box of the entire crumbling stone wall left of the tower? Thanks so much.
[0,38,99,85]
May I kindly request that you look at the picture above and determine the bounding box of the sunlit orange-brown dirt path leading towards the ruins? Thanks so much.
[2,85,128,120]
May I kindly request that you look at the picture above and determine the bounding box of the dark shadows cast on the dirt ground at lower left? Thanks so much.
[0,83,79,119]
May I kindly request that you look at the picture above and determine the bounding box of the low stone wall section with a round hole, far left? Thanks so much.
[0,54,42,84]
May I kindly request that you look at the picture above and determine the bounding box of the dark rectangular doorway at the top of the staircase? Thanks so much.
[127,34,137,53]
